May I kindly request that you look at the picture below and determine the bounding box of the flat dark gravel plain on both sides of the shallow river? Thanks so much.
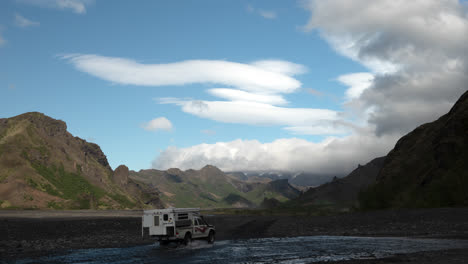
[0,208,468,264]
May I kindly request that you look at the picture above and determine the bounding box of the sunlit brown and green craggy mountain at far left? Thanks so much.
[0,112,163,209]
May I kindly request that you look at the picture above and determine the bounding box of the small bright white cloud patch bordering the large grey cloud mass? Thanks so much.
[338,72,374,100]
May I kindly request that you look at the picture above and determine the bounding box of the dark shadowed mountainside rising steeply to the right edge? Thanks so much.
[360,91,468,209]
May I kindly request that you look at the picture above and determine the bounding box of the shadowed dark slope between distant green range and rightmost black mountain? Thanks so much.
[294,157,385,208]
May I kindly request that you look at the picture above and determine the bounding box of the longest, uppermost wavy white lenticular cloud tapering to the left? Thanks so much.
[63,54,301,93]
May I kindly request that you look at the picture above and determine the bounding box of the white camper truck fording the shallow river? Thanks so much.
[142,208,216,245]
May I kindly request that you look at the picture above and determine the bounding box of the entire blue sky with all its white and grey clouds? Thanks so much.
[0,0,468,175]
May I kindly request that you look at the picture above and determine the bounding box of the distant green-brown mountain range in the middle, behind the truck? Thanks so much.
[130,165,300,208]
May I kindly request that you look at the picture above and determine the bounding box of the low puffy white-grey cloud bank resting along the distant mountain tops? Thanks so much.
[153,133,396,175]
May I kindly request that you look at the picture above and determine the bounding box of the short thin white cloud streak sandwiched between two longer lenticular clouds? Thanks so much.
[208,88,288,105]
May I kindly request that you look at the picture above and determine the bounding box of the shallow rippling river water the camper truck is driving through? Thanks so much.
[17,236,468,264]
